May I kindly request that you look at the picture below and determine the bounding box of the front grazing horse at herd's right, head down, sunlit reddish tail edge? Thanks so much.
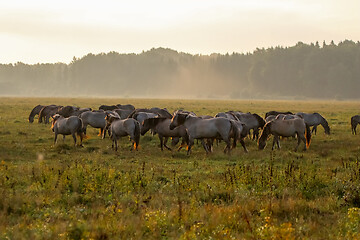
[259,119,311,151]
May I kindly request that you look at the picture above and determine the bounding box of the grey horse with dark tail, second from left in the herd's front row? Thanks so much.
[105,113,140,151]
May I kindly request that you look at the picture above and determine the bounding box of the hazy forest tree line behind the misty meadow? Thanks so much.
[0,40,360,99]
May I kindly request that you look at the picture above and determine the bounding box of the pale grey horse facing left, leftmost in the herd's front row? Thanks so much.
[51,114,85,146]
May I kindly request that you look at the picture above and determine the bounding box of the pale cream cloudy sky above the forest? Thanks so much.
[0,0,360,64]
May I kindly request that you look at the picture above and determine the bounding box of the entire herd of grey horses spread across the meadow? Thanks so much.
[29,104,360,154]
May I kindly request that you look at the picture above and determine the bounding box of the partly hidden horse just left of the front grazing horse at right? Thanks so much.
[227,111,265,140]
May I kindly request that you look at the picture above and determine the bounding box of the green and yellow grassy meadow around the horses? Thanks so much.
[0,98,360,239]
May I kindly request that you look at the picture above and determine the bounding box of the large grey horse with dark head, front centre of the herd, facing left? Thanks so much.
[170,113,238,155]
